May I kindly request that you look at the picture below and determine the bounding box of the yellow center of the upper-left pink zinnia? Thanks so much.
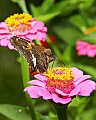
[5,13,32,32]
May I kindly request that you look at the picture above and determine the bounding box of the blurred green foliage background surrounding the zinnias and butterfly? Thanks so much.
[0,0,96,120]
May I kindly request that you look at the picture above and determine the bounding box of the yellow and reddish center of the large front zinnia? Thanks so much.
[44,67,75,93]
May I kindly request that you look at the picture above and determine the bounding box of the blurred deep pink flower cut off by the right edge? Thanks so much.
[76,40,96,57]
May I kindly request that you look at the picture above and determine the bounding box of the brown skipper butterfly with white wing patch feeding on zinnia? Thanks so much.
[10,36,55,73]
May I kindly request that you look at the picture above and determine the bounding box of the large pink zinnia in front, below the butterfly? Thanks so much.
[24,67,96,104]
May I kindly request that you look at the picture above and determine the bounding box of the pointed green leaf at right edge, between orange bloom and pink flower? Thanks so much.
[79,32,96,44]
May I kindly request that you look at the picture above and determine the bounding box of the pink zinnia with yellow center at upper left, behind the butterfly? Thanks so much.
[0,13,47,49]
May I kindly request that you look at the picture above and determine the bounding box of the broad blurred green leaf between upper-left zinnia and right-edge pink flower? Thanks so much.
[53,23,81,45]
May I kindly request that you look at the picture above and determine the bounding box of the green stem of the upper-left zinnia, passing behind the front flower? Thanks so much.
[20,56,36,120]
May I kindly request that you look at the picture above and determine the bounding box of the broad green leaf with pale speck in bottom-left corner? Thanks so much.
[0,104,32,120]
